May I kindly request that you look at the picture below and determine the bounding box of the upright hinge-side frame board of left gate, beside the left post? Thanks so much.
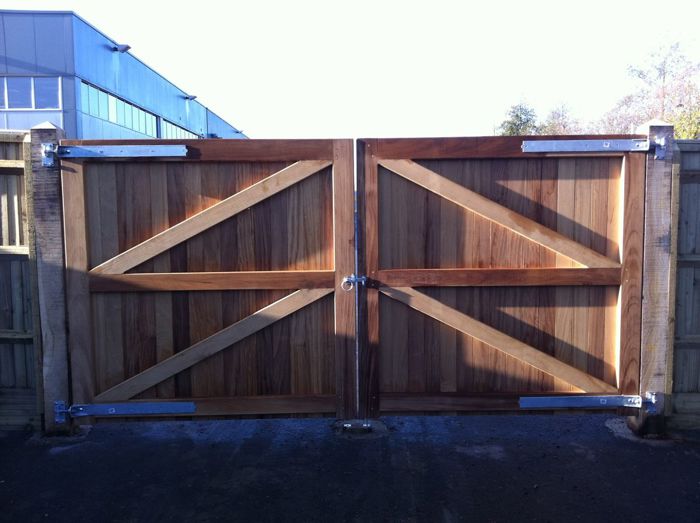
[61,161,95,403]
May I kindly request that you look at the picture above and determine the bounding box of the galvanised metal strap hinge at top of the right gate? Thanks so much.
[522,137,666,160]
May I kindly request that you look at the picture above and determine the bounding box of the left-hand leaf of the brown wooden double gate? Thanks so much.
[57,140,355,416]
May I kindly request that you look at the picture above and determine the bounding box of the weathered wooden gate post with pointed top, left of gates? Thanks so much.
[26,123,70,433]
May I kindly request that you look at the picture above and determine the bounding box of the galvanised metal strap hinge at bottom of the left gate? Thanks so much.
[53,401,196,423]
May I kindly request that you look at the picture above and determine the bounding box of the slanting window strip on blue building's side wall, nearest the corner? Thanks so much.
[80,82,158,138]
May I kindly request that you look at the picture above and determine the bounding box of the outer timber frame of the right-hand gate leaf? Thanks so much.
[357,134,652,417]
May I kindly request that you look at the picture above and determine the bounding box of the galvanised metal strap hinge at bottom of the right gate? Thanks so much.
[520,392,656,414]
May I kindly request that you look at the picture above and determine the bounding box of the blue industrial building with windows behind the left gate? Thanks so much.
[0,10,246,139]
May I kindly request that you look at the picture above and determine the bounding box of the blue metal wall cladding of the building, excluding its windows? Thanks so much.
[0,10,246,138]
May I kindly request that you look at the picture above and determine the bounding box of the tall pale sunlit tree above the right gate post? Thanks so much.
[597,43,700,138]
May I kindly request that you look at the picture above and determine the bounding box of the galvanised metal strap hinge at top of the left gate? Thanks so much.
[41,143,187,167]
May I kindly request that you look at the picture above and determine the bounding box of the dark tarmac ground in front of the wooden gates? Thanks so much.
[0,415,700,522]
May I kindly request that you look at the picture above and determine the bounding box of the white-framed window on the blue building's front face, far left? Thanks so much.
[0,76,61,110]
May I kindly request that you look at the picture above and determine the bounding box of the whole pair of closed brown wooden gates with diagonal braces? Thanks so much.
[62,137,646,418]
